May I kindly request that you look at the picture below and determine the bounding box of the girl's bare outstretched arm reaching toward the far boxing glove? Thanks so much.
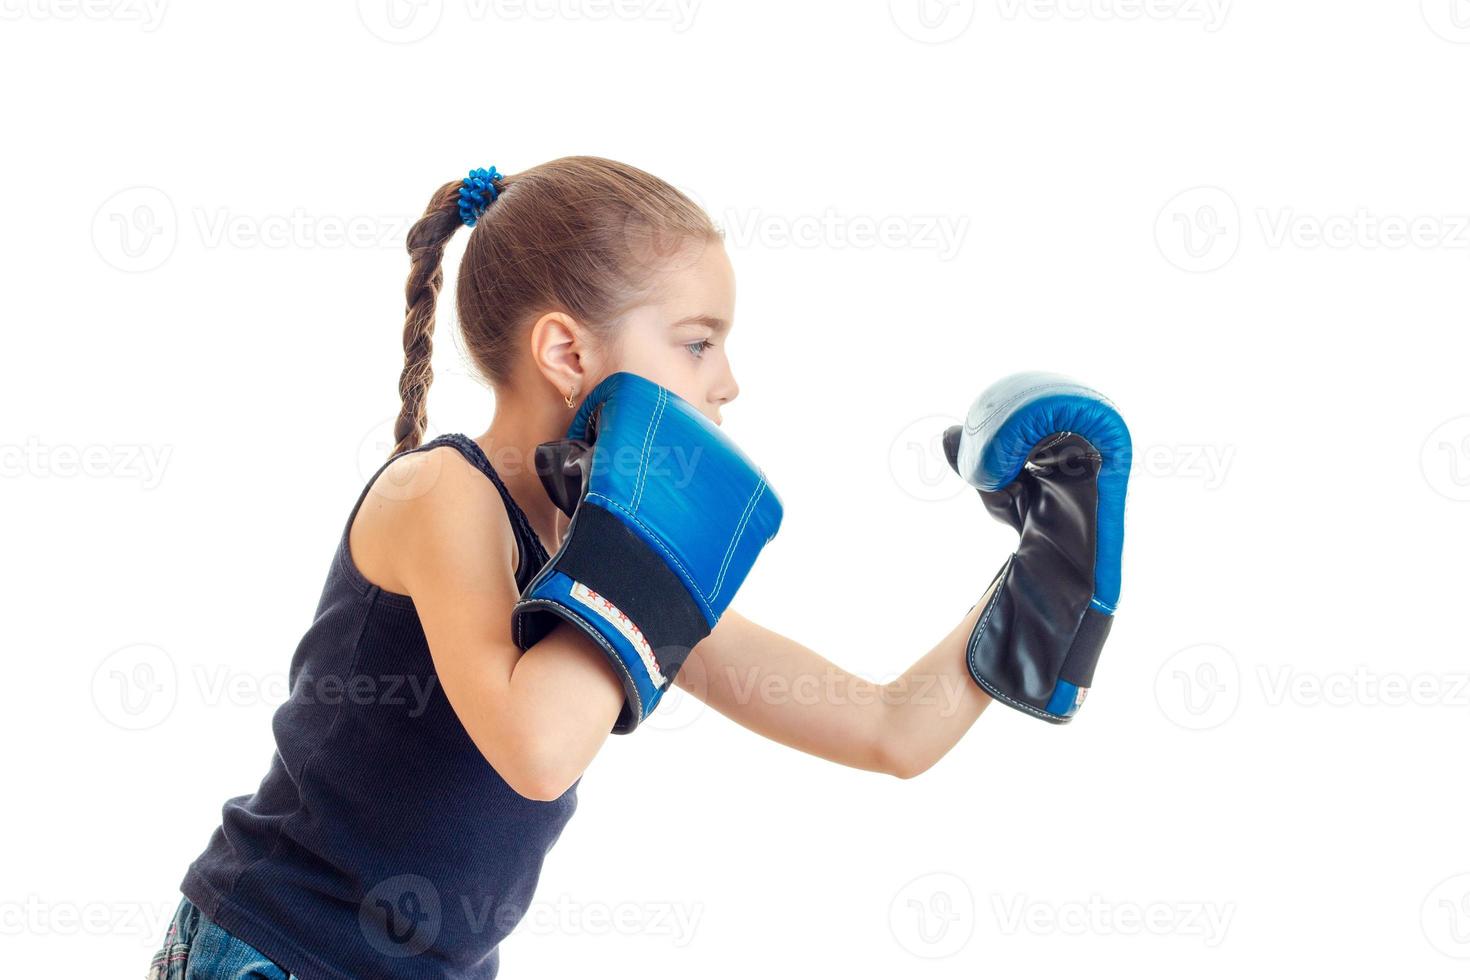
[675,582,994,779]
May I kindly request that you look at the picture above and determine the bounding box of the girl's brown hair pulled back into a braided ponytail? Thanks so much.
[392,156,720,454]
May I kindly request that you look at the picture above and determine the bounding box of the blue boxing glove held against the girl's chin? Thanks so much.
[510,372,782,735]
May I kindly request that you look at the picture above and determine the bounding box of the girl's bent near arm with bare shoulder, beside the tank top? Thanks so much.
[379,447,623,801]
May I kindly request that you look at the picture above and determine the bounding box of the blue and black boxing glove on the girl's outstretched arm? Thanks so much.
[944,372,1132,724]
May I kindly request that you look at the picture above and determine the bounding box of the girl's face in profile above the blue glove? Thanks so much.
[607,241,739,425]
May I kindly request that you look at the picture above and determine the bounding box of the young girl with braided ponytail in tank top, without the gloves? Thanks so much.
[148,157,989,980]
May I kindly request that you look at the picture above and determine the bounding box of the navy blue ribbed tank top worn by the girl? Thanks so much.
[182,432,581,980]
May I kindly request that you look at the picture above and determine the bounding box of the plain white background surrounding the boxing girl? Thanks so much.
[0,0,1470,977]
